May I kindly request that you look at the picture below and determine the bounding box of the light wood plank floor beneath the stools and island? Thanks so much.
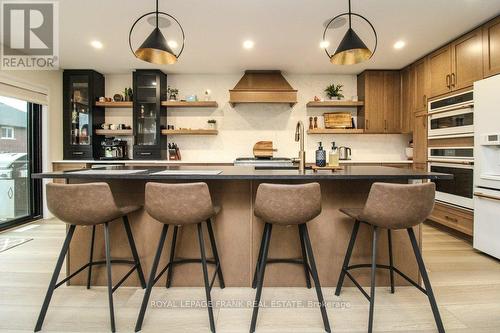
[0,220,500,333]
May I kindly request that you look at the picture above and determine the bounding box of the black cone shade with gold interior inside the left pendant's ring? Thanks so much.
[134,28,177,65]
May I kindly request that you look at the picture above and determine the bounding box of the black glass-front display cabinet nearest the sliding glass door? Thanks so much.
[63,70,104,160]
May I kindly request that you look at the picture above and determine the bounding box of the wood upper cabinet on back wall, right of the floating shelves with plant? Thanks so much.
[358,71,401,133]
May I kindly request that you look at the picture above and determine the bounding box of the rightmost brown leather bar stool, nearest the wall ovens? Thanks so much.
[335,183,444,332]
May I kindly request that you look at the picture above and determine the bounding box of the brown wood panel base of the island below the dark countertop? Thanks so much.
[67,180,420,287]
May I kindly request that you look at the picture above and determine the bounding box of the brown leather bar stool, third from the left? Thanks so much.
[250,183,330,333]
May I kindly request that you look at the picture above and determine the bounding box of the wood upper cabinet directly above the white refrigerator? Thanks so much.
[482,17,500,77]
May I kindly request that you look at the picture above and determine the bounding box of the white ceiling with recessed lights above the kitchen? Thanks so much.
[59,0,500,74]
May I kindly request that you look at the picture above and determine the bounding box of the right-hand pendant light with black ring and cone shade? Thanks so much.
[323,0,377,65]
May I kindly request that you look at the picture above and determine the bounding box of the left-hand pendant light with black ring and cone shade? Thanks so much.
[128,0,185,65]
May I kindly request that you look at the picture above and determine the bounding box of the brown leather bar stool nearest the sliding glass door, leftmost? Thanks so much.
[35,183,146,332]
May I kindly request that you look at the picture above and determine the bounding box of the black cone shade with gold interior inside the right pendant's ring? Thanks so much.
[330,28,372,65]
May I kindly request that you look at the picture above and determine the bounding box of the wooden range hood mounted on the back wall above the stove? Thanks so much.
[229,70,297,107]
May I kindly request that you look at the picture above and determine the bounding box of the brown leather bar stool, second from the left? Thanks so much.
[135,183,224,332]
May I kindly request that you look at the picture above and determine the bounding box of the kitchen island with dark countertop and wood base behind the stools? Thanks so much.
[33,166,452,287]
